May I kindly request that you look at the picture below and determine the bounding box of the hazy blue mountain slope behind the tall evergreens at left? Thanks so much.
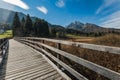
[0,8,36,24]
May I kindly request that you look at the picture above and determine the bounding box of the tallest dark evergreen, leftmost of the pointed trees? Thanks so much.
[12,12,21,36]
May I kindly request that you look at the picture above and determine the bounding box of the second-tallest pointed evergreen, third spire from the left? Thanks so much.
[25,14,32,36]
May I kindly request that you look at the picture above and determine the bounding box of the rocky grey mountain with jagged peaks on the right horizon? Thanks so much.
[66,21,120,33]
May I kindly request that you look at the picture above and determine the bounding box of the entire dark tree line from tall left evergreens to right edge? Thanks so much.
[12,12,120,38]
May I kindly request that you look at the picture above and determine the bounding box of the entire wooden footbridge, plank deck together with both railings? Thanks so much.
[0,37,120,80]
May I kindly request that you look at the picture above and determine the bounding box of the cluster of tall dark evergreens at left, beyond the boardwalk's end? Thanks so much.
[12,12,50,37]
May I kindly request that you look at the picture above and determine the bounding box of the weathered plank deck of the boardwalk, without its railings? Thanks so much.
[0,39,65,80]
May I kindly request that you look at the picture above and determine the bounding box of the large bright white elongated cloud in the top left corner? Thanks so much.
[3,0,29,10]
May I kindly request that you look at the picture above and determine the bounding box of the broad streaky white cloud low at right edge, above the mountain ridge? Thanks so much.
[101,11,120,29]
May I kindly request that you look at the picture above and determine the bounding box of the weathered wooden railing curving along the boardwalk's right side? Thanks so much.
[16,37,120,80]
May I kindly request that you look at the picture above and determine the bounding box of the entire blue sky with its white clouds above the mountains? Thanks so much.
[0,0,120,28]
